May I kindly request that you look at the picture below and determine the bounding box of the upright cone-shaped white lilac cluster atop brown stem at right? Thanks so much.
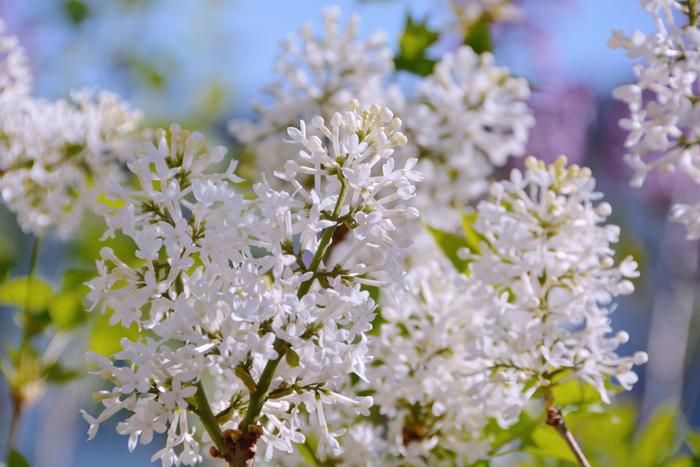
[468,156,646,416]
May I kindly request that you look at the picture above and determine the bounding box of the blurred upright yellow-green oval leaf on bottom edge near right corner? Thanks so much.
[633,405,678,466]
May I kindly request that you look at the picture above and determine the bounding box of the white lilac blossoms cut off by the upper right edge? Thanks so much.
[609,0,700,239]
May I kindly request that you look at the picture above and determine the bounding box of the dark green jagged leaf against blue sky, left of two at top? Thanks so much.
[394,14,440,76]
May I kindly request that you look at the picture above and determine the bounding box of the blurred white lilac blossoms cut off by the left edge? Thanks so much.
[0,24,141,238]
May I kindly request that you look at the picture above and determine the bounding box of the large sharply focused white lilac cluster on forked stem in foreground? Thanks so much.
[85,101,419,465]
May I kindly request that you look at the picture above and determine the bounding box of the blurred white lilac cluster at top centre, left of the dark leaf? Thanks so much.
[229,7,393,180]
